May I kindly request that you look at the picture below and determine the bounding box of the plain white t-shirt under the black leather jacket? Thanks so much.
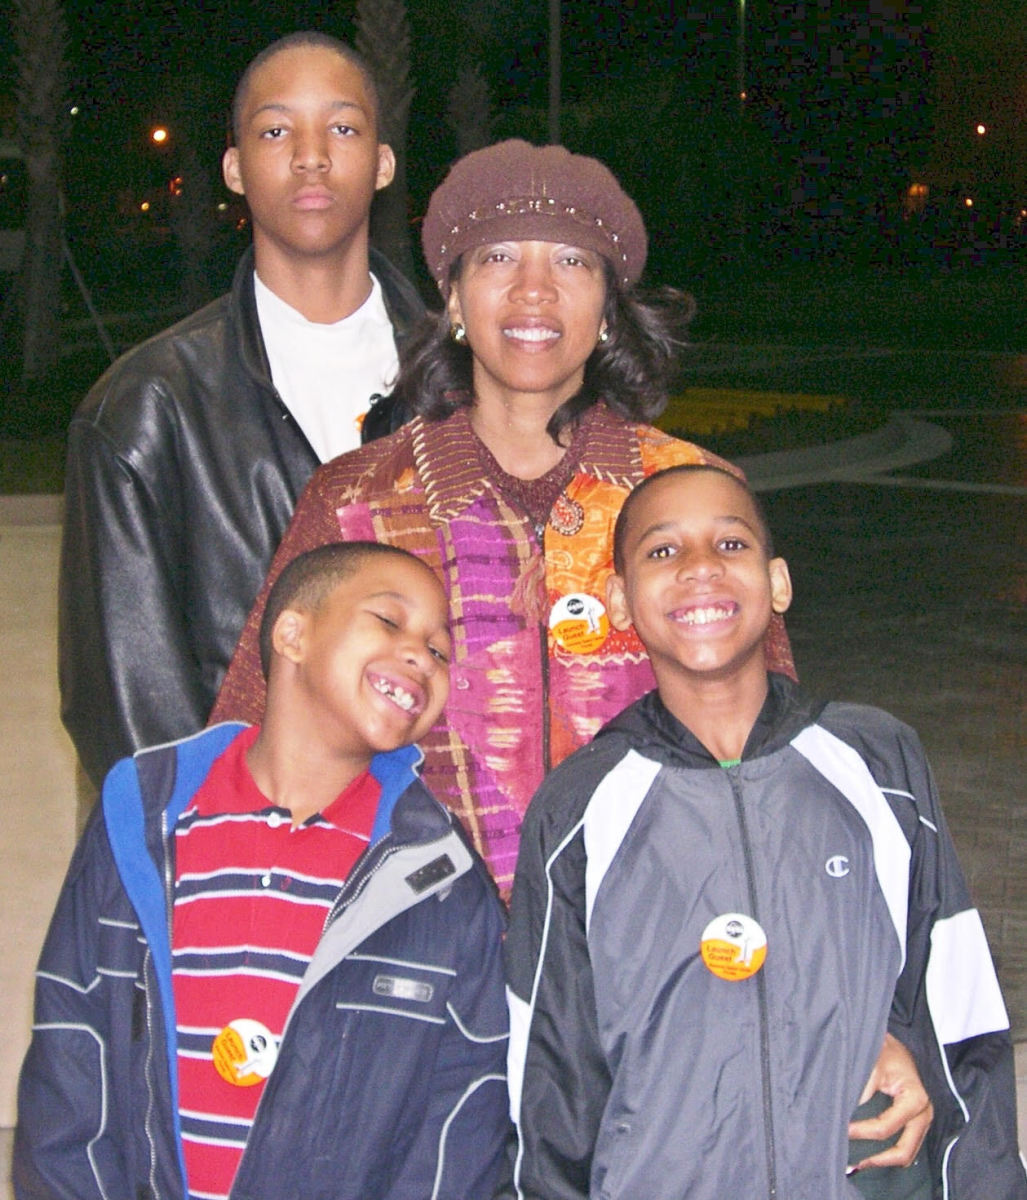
[253,274,400,462]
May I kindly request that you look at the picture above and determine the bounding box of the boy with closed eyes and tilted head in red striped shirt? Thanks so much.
[14,542,509,1200]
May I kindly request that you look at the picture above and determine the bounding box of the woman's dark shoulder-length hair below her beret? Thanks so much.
[391,260,695,444]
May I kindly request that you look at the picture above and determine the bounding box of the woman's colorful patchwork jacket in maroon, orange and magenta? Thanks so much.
[211,406,793,895]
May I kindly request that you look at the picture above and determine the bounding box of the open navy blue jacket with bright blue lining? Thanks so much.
[14,724,509,1200]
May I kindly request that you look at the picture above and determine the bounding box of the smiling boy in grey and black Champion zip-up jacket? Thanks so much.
[506,467,1027,1200]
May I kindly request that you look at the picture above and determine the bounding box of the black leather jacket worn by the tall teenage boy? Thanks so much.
[58,250,424,784]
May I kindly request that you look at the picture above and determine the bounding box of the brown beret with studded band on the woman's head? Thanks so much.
[421,138,647,292]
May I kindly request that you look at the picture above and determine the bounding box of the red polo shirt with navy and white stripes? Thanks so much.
[172,728,380,1200]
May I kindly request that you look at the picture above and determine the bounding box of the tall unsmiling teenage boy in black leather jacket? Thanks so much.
[59,32,424,785]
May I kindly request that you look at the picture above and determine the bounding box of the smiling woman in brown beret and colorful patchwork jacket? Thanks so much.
[214,140,791,893]
